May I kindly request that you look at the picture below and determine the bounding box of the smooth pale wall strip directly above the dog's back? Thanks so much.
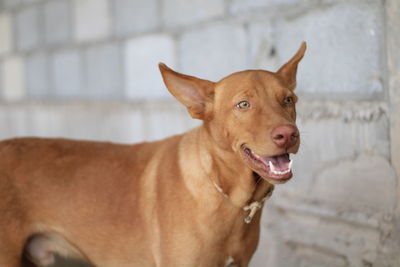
[0,101,200,143]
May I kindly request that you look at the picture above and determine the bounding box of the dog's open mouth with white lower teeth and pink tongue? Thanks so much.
[241,145,293,183]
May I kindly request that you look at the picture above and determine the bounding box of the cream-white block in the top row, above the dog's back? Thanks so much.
[73,0,111,41]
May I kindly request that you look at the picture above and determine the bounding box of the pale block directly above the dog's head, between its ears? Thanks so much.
[178,22,249,80]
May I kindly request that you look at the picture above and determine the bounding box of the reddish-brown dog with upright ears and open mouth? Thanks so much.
[0,43,306,267]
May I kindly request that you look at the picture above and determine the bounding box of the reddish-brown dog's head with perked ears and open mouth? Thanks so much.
[159,42,306,184]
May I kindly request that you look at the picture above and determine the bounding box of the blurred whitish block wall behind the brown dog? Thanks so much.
[0,0,400,267]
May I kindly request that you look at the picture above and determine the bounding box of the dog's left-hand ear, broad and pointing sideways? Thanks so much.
[158,63,215,120]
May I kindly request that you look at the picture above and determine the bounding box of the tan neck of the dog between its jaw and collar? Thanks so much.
[197,126,273,208]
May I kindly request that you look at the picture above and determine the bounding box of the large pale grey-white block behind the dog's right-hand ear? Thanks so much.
[276,1,384,98]
